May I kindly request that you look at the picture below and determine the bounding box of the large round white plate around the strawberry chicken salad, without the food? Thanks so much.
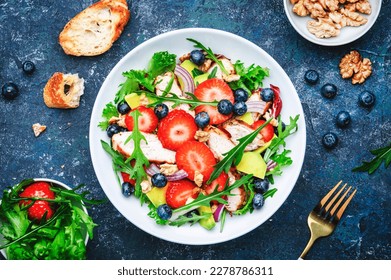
[90,28,306,245]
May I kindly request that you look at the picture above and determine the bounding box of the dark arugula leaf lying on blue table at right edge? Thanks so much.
[352,142,391,174]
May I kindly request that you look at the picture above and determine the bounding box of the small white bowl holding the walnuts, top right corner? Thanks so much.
[284,0,382,46]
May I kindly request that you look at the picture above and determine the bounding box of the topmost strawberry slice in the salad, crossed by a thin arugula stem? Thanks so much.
[194,78,234,124]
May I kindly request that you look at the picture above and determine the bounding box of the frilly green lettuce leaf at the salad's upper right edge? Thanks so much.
[229,60,269,93]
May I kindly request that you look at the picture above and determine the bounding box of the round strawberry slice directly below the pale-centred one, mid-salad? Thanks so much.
[175,141,216,182]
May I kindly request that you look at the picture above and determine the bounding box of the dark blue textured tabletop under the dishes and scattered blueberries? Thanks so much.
[0,0,391,259]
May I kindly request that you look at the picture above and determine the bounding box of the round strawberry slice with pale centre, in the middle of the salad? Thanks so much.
[157,109,198,151]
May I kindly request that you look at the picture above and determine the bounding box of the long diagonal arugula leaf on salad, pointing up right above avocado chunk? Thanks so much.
[207,119,271,184]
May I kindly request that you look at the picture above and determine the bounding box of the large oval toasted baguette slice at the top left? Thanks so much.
[59,0,130,56]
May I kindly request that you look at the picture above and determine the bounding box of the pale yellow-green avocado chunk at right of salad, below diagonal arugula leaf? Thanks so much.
[236,151,266,179]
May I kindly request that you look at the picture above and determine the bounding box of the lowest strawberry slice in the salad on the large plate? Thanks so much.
[166,179,198,208]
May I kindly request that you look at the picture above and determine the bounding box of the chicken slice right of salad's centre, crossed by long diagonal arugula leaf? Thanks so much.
[223,120,265,151]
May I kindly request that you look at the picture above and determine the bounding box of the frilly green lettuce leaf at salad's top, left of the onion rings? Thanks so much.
[147,51,176,79]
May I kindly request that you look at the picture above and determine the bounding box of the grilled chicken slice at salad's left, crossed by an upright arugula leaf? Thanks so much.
[111,131,175,163]
